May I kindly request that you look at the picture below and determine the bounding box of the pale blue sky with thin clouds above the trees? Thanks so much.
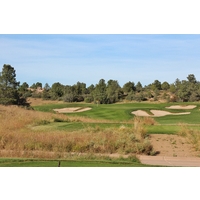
[0,34,200,86]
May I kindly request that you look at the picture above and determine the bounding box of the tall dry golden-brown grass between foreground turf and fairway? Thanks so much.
[0,106,153,157]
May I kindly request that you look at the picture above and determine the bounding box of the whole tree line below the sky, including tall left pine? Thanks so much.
[0,64,200,105]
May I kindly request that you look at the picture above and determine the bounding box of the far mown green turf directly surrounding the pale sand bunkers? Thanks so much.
[34,103,200,124]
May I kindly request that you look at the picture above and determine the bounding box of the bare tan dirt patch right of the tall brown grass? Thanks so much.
[150,134,199,157]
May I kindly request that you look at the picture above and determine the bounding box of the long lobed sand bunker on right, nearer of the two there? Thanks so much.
[132,110,190,117]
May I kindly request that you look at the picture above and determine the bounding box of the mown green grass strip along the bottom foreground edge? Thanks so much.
[0,158,155,167]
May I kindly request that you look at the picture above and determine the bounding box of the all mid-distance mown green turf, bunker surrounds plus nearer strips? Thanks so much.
[34,102,200,134]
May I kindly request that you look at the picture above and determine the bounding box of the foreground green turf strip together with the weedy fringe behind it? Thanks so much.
[0,155,155,167]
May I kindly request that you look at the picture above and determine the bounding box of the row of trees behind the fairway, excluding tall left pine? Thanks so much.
[23,74,200,104]
